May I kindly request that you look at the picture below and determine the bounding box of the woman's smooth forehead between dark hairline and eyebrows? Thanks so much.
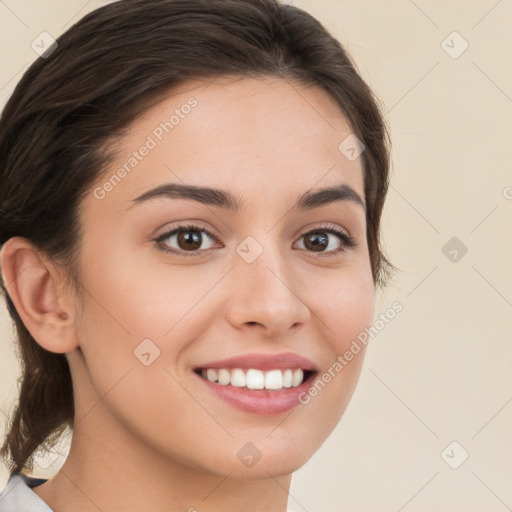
[91,77,364,211]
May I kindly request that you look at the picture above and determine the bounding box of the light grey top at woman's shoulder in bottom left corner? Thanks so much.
[0,473,53,512]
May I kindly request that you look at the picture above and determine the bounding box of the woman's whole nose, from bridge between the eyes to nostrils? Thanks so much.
[228,234,309,336]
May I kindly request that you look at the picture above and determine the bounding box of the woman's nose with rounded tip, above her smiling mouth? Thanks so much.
[226,242,310,338]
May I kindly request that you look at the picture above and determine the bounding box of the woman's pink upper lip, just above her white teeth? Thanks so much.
[195,352,316,371]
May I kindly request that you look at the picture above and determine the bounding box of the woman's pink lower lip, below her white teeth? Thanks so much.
[194,373,315,414]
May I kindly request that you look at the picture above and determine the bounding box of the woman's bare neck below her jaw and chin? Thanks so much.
[33,402,291,512]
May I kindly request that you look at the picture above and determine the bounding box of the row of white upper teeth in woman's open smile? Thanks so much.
[201,368,304,389]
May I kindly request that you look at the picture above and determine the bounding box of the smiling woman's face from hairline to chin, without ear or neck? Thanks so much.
[67,78,374,479]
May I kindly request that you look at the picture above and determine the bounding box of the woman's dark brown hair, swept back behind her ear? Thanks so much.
[0,0,394,474]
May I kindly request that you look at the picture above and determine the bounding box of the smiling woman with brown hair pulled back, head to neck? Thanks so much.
[0,0,392,512]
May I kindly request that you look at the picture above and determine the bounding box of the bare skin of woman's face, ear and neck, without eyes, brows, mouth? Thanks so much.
[2,78,375,512]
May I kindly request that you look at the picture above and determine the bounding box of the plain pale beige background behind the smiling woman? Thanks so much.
[0,0,512,512]
